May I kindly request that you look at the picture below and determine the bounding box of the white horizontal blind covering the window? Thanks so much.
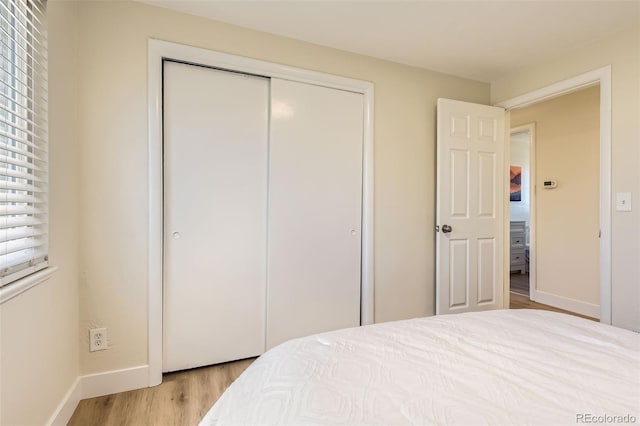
[0,0,48,285]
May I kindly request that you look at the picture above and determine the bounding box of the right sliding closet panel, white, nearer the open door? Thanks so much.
[267,79,364,348]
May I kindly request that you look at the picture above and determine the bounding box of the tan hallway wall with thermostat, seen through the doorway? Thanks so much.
[511,86,600,305]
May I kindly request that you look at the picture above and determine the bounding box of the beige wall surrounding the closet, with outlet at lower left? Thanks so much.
[72,2,489,373]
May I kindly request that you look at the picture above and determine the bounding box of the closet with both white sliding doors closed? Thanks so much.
[163,61,364,371]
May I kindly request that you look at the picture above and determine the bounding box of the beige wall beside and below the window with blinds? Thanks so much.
[0,3,79,426]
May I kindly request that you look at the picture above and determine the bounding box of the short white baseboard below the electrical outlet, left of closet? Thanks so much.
[80,365,149,399]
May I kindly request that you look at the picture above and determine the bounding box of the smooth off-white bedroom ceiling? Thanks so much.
[142,0,640,82]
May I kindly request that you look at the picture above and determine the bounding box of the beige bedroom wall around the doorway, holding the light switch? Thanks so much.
[491,29,640,331]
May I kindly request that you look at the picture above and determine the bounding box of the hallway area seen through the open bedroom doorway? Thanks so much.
[509,85,601,318]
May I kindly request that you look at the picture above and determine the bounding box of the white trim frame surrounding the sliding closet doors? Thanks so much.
[147,39,374,386]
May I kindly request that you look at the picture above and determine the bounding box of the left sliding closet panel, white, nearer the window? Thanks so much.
[163,62,269,371]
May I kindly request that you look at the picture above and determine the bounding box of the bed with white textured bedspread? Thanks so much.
[201,310,640,425]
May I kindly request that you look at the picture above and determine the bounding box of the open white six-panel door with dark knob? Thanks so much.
[436,99,505,314]
